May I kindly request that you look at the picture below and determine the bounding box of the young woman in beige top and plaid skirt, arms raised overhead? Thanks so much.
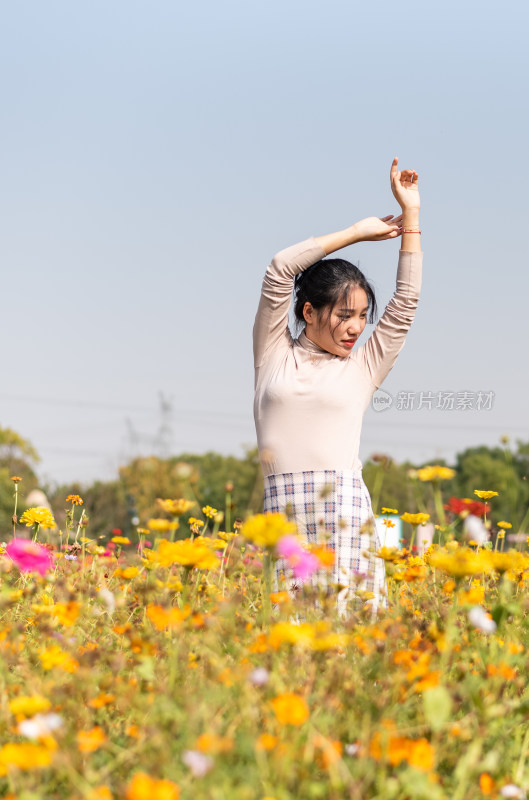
[254,158,422,610]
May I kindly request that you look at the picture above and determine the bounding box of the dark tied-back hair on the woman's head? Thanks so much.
[294,258,377,332]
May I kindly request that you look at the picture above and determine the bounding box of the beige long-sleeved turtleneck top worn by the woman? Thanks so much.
[253,238,422,476]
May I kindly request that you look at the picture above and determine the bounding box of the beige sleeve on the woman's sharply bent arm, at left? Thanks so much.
[253,237,326,369]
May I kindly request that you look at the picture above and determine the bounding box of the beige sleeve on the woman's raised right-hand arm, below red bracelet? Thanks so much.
[354,250,422,387]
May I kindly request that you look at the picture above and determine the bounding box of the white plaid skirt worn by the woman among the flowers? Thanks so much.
[264,470,387,613]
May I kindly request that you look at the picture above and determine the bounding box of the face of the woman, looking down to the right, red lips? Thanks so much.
[303,286,369,358]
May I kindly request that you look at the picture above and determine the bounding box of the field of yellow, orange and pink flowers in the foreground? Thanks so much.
[0,478,529,800]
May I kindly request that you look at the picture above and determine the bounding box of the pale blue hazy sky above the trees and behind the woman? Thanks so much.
[0,0,529,482]
